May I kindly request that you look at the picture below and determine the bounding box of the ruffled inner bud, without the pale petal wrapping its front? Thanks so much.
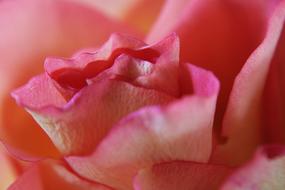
[12,34,180,155]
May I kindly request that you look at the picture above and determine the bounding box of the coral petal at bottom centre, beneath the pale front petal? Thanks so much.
[134,161,232,190]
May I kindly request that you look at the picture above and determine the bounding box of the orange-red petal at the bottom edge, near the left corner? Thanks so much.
[8,160,111,190]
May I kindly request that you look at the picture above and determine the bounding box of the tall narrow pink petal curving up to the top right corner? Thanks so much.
[213,1,285,164]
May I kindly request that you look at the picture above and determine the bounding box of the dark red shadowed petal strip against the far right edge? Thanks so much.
[262,23,285,144]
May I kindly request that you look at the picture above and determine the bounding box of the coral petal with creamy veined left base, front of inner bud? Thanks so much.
[13,75,173,155]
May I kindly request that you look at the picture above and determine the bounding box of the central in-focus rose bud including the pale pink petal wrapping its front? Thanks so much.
[13,31,218,189]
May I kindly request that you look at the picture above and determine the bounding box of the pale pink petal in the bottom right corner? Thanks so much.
[222,146,285,190]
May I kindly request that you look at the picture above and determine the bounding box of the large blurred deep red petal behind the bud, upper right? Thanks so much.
[148,0,280,128]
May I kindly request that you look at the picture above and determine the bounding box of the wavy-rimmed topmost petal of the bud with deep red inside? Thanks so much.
[45,34,180,96]
